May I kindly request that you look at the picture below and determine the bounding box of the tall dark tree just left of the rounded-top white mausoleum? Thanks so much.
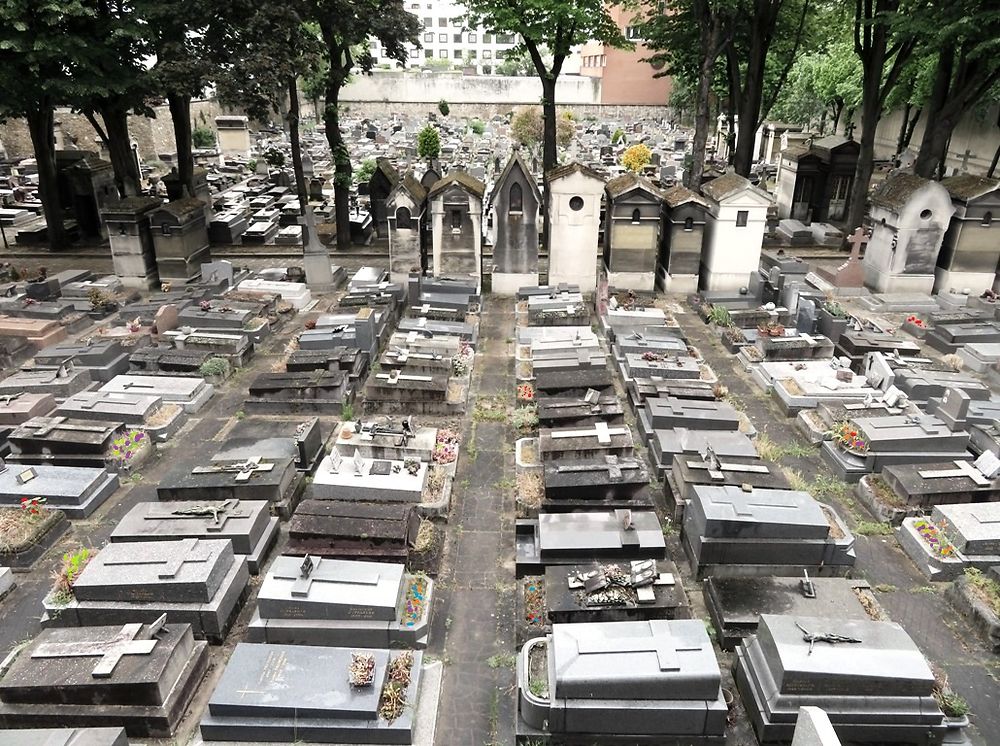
[847,0,922,229]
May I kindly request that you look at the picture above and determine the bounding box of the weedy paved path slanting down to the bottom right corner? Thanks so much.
[678,312,1000,745]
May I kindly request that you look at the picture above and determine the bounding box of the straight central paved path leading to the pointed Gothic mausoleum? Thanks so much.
[430,296,515,746]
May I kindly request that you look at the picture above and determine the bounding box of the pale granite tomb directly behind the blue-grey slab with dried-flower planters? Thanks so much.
[247,555,434,649]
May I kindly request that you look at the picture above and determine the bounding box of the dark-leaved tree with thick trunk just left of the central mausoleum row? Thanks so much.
[306,0,423,249]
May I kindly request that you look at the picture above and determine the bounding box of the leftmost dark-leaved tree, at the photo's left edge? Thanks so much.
[0,0,93,249]
